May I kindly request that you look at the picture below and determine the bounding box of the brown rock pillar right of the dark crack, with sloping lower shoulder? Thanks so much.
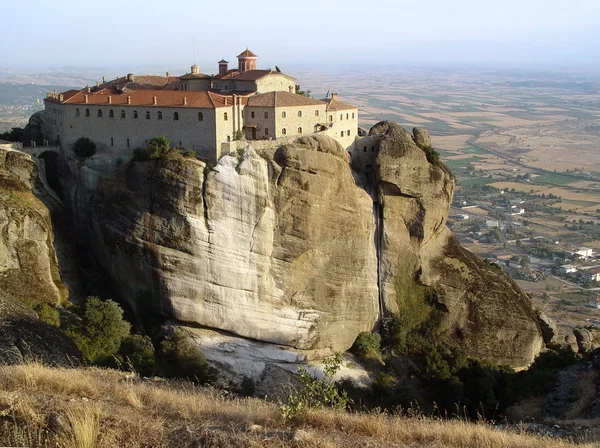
[371,122,543,367]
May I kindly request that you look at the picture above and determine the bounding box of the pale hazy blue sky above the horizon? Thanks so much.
[0,0,600,74]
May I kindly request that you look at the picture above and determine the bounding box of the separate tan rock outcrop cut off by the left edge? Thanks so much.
[0,151,67,304]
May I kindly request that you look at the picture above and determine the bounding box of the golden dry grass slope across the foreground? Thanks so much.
[0,364,593,448]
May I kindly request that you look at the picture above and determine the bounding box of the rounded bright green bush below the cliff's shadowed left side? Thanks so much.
[66,297,131,363]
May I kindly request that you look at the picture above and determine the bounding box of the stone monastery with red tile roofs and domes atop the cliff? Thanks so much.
[44,50,359,162]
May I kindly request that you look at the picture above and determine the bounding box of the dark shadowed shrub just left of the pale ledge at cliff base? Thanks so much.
[159,331,214,384]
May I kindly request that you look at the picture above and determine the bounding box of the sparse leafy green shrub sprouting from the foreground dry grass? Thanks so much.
[280,353,350,420]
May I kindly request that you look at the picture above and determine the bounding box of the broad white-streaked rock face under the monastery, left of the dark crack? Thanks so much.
[91,138,378,350]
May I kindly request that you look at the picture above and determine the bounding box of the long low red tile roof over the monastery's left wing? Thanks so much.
[45,88,247,109]
